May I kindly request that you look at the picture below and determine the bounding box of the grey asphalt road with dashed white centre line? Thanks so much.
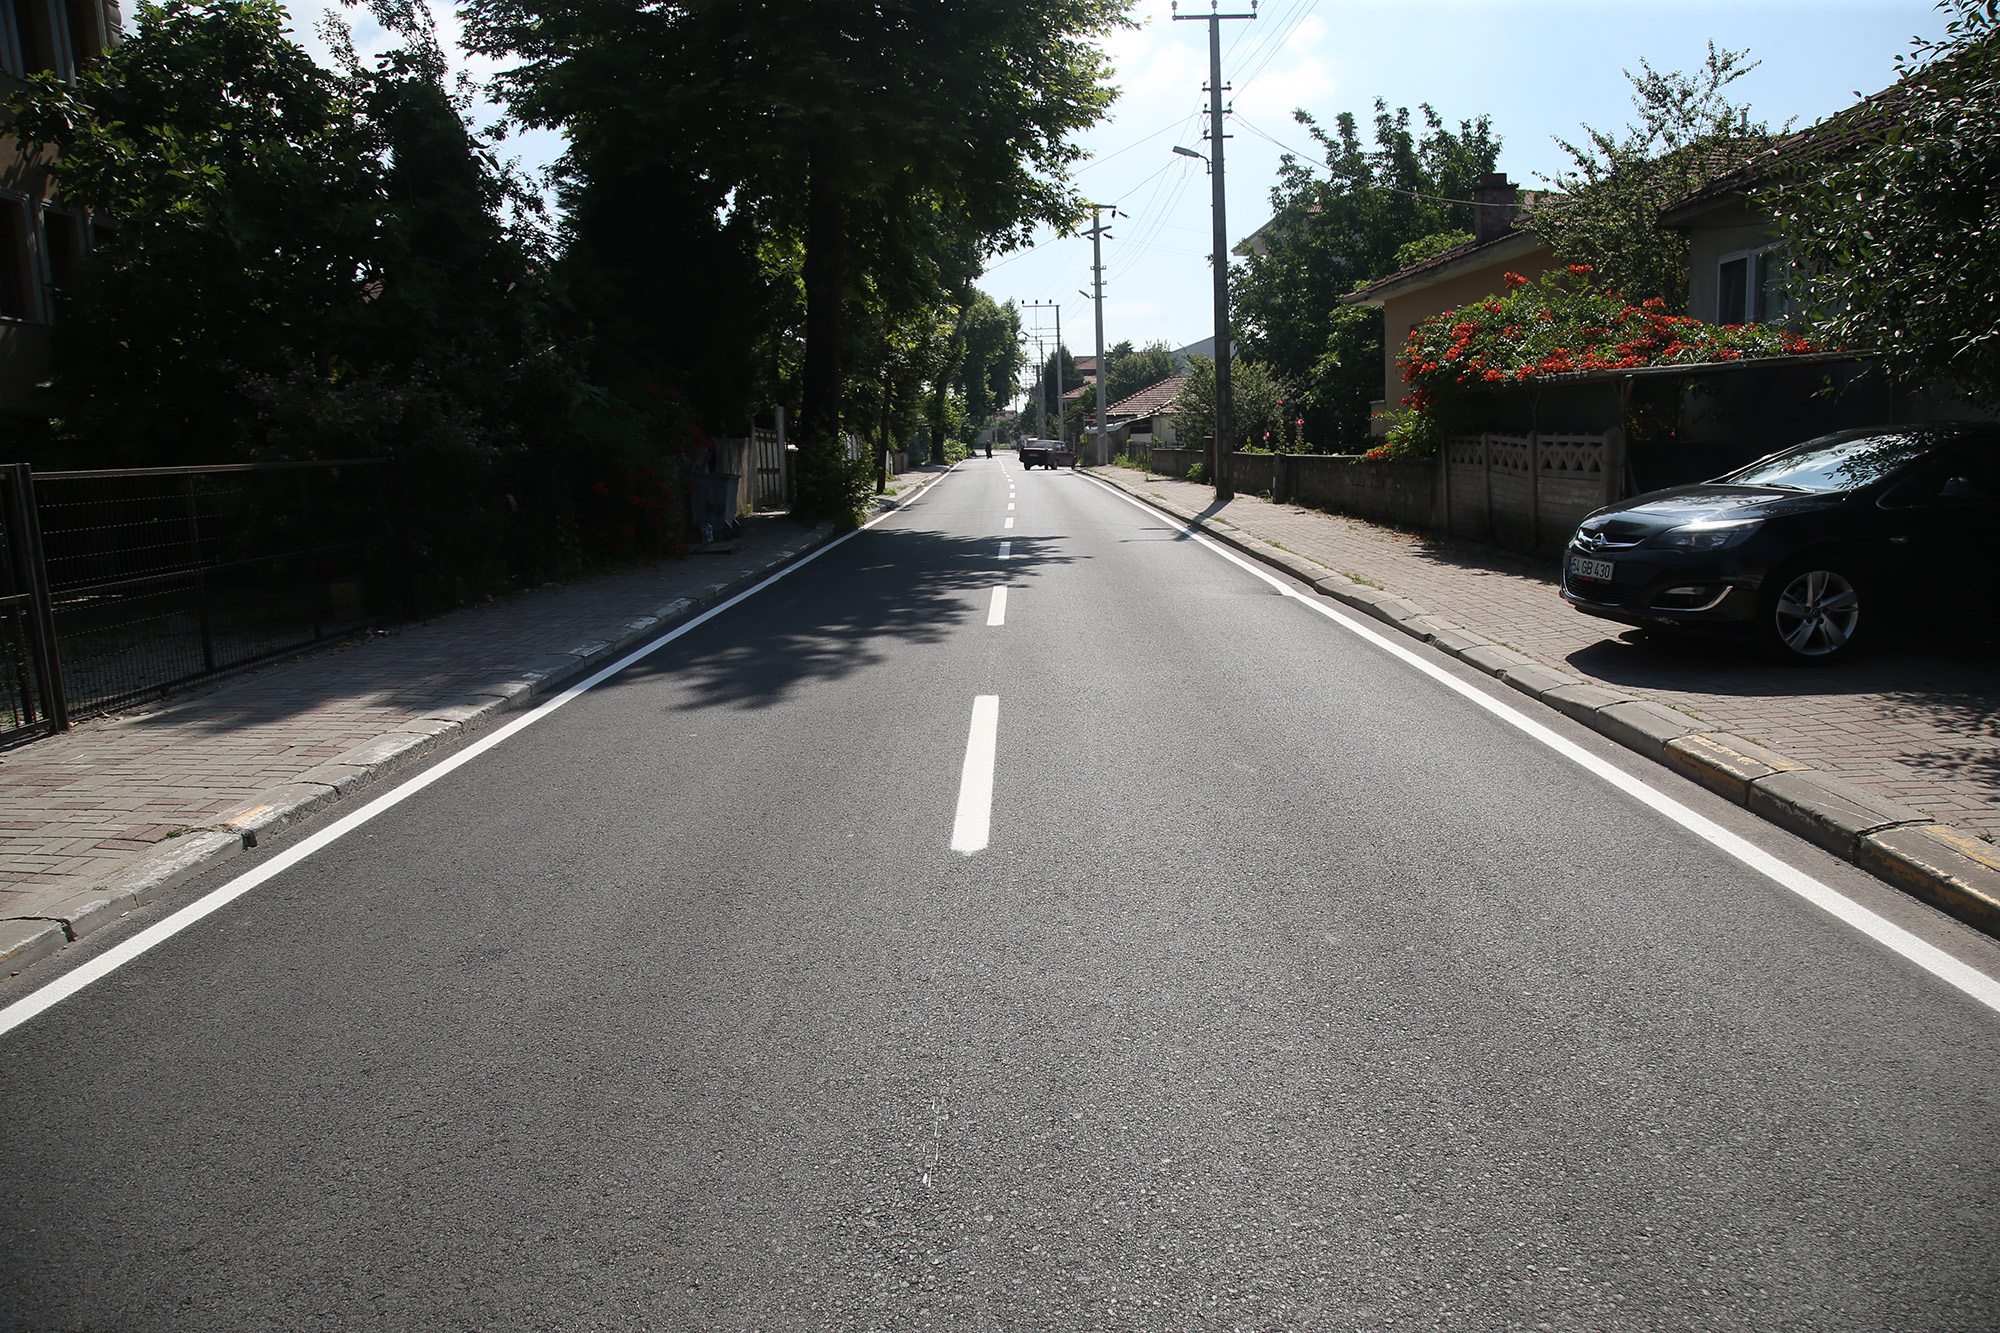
[0,454,2000,1333]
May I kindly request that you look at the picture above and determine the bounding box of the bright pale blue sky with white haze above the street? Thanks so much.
[294,0,1946,366]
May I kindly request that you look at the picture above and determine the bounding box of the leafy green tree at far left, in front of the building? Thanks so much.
[12,0,388,464]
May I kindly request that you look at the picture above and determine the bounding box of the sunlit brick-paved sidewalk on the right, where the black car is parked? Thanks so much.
[1092,468,2000,843]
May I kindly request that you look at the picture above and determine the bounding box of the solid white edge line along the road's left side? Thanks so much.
[0,464,956,1037]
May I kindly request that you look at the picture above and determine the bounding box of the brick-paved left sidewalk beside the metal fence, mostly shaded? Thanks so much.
[0,498,852,915]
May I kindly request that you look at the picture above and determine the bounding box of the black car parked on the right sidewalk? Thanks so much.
[1562,422,2000,662]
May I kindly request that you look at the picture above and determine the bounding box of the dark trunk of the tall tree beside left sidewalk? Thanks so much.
[798,148,848,518]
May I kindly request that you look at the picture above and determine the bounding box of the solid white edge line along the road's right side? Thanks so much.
[1086,472,2000,1013]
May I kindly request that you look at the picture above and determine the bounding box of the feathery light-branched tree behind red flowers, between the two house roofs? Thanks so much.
[1526,42,1772,314]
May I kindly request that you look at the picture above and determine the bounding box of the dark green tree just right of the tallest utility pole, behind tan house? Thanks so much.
[1234,102,1500,448]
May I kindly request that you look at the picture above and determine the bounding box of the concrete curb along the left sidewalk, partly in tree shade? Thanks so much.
[0,512,844,975]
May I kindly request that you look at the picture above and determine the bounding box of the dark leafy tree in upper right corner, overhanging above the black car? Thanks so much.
[1764,0,2000,402]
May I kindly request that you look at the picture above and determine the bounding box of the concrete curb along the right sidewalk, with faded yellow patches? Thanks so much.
[1092,472,2000,937]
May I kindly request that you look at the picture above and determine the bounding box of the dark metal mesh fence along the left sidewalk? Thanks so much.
[0,458,412,731]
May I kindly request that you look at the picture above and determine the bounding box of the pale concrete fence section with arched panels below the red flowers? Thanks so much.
[1436,430,1624,552]
